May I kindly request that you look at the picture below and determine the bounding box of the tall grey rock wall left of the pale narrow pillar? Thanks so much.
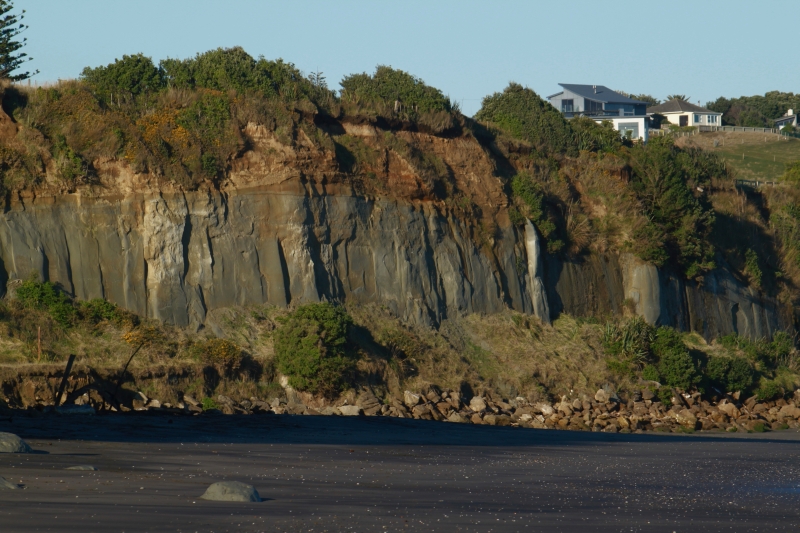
[0,184,532,327]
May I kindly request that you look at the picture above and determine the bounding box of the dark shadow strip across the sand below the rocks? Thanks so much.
[0,413,800,447]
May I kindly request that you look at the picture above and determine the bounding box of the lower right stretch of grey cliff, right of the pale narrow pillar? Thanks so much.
[545,254,792,339]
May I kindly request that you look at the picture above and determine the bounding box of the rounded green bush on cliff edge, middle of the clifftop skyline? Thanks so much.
[340,65,453,114]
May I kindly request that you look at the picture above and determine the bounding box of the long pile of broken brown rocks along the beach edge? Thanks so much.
[25,387,800,433]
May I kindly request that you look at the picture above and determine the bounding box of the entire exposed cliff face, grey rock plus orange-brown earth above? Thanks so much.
[0,121,788,337]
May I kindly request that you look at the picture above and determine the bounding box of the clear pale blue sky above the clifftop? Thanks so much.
[14,0,800,115]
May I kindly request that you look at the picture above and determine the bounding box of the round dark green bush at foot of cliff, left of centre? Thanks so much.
[275,303,355,397]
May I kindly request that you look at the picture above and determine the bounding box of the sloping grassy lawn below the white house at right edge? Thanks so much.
[679,132,800,180]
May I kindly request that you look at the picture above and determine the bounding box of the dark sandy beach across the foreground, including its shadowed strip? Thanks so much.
[0,412,800,532]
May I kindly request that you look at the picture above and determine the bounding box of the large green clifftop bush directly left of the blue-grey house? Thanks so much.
[475,83,575,154]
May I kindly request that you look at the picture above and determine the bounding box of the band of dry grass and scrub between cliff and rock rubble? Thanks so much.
[0,279,800,410]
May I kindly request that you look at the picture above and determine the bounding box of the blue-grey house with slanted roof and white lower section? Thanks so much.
[547,83,648,142]
